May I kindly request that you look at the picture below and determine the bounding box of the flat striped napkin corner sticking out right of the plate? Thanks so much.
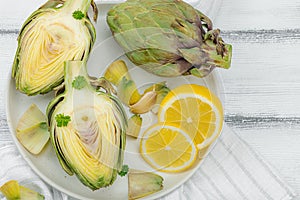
[163,124,296,200]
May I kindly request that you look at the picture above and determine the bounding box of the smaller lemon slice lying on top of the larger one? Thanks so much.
[140,123,198,172]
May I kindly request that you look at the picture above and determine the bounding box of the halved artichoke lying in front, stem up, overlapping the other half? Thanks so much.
[47,61,127,190]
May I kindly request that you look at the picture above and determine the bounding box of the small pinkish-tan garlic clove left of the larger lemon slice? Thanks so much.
[129,91,157,114]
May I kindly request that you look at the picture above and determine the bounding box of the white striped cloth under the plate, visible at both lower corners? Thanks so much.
[0,124,296,200]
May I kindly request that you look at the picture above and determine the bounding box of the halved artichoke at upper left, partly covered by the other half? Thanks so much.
[12,0,98,95]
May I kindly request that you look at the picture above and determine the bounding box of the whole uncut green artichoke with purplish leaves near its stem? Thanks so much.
[107,0,232,77]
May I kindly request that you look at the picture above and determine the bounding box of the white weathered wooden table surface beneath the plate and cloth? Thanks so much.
[0,0,300,197]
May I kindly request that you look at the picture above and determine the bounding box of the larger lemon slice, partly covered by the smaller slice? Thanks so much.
[158,84,223,149]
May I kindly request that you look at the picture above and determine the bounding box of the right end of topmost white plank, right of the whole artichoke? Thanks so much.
[215,0,300,30]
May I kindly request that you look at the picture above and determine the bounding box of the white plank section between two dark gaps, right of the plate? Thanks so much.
[219,30,300,117]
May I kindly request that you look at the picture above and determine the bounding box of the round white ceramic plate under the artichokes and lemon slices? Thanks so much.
[7,1,223,200]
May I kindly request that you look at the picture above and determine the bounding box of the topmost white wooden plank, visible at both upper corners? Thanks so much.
[0,0,300,30]
